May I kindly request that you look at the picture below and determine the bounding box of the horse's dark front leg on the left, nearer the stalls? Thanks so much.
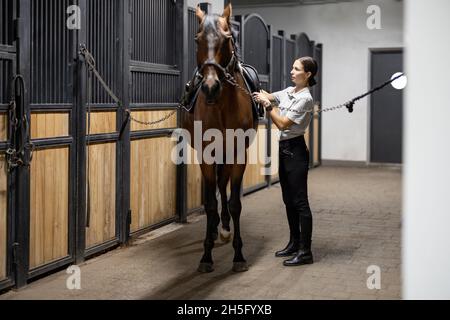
[197,164,220,272]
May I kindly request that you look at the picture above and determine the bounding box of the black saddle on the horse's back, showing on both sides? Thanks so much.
[180,64,264,118]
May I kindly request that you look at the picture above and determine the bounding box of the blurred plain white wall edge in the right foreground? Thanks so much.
[402,0,450,299]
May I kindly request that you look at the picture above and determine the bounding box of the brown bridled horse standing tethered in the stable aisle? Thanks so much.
[182,4,258,272]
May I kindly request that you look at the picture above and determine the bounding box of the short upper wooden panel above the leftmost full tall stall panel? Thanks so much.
[30,112,69,139]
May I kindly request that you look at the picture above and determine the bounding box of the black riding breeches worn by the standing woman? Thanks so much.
[279,136,312,249]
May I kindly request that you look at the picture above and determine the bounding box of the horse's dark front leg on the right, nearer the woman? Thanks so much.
[229,164,248,272]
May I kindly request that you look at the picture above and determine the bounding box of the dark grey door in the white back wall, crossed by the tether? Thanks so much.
[370,49,403,163]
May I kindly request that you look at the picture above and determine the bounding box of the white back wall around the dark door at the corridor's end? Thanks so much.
[233,0,403,161]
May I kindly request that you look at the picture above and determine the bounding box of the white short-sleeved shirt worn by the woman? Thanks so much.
[272,87,314,140]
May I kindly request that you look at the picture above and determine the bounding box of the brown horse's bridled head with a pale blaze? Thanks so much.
[195,4,234,104]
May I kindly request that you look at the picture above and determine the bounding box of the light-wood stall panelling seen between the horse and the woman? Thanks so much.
[243,124,267,190]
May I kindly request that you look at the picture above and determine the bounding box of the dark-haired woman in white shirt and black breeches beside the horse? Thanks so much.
[253,57,318,266]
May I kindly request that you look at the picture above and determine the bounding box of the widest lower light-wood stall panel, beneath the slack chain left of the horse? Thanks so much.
[130,137,176,232]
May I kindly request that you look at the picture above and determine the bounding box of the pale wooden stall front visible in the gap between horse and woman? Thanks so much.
[243,124,267,190]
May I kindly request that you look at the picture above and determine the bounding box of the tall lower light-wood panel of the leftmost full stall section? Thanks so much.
[30,147,69,269]
